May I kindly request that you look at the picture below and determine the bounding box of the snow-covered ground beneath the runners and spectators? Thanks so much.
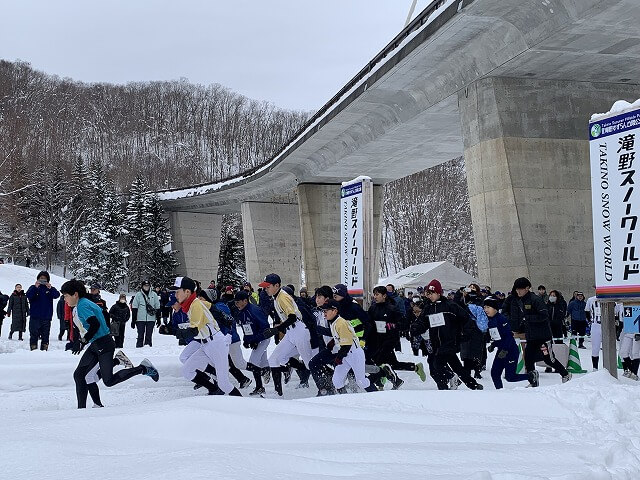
[0,267,640,480]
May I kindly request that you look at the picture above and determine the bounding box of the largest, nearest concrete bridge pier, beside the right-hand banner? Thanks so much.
[458,77,640,297]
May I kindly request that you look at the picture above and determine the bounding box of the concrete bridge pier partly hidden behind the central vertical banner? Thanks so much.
[298,183,383,293]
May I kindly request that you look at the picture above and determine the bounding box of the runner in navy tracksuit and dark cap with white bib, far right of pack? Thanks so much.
[483,297,538,390]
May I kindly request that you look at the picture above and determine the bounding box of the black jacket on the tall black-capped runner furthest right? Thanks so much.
[505,292,551,342]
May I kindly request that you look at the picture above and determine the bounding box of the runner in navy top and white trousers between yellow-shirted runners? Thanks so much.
[233,290,270,395]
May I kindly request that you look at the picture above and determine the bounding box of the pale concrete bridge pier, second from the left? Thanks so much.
[241,202,301,288]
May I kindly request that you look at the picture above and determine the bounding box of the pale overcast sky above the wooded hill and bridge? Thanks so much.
[0,0,429,110]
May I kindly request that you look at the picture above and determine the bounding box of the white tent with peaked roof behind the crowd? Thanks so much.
[380,262,478,290]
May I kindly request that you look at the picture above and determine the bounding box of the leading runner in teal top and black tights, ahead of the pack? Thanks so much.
[61,279,159,408]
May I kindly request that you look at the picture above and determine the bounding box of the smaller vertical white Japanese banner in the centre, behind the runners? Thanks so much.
[340,177,373,304]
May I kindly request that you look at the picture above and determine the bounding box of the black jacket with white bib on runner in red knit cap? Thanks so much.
[411,297,472,355]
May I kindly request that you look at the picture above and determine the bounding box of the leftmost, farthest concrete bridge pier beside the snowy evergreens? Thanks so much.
[169,212,222,286]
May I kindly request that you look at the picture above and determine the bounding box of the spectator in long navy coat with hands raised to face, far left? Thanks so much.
[27,270,60,350]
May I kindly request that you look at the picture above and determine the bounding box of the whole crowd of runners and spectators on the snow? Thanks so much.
[6,271,640,408]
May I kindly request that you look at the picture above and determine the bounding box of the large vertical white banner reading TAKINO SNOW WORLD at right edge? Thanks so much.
[589,105,640,300]
